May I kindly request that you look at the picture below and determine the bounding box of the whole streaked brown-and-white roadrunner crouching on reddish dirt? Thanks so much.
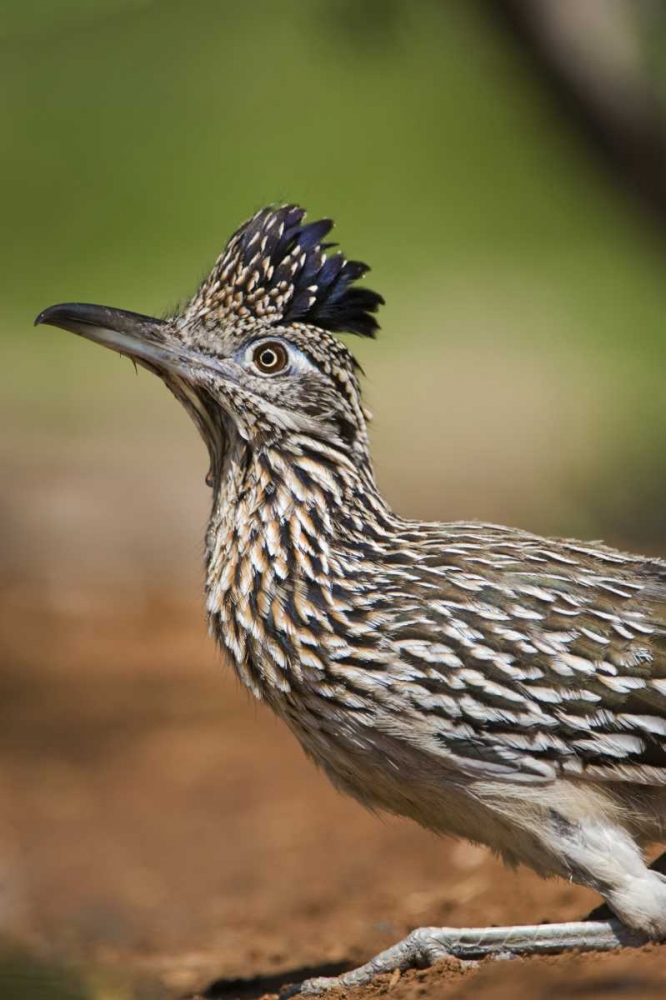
[36,205,666,992]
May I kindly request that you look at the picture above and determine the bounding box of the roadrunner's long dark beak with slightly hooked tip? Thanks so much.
[35,302,185,374]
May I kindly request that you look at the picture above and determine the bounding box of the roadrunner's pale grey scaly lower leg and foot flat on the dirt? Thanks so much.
[286,919,648,996]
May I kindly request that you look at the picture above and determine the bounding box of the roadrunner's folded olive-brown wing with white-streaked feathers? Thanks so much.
[368,525,666,785]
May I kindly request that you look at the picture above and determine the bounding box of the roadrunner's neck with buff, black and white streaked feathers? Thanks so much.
[206,436,391,696]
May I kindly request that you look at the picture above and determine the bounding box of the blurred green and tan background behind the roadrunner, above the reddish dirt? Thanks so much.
[0,0,666,586]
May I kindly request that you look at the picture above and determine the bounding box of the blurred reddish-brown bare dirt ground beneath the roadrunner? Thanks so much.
[0,586,666,1000]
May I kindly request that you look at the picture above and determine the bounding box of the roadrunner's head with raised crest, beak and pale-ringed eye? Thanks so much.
[36,205,383,484]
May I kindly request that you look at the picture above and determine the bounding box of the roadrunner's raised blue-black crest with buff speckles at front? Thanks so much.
[188,205,384,337]
